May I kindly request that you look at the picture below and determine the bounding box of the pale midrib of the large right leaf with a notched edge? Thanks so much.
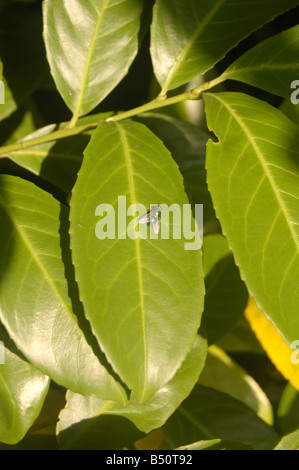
[213,95,299,253]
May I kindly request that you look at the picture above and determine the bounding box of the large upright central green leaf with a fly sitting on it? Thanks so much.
[70,122,204,401]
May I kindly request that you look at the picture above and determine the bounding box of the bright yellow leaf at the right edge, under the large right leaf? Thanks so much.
[245,297,299,390]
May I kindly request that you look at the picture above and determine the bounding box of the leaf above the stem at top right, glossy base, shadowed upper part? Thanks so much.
[151,0,298,92]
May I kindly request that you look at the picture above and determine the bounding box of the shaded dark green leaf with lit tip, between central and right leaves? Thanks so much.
[202,234,248,344]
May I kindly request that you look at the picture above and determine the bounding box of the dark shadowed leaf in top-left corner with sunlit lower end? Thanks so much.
[0,4,49,120]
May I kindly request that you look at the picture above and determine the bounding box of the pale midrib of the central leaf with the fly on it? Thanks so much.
[115,123,147,396]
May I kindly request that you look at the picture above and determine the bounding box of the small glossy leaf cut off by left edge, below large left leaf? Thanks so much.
[0,324,50,444]
